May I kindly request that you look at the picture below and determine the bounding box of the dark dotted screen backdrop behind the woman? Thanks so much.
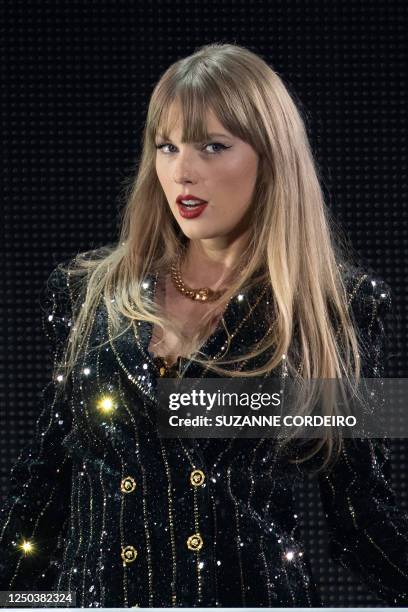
[0,0,408,606]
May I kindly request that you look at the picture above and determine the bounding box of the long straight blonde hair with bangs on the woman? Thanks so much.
[56,43,360,474]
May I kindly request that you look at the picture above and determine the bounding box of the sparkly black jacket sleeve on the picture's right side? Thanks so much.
[319,276,408,605]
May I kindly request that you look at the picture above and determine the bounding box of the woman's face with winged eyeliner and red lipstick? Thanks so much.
[155,104,258,240]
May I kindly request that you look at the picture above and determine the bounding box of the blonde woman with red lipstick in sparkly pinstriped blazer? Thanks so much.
[0,44,408,607]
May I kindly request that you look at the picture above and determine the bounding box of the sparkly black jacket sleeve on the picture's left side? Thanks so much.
[0,267,72,591]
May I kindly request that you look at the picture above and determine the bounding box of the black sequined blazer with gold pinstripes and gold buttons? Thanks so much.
[0,255,408,607]
